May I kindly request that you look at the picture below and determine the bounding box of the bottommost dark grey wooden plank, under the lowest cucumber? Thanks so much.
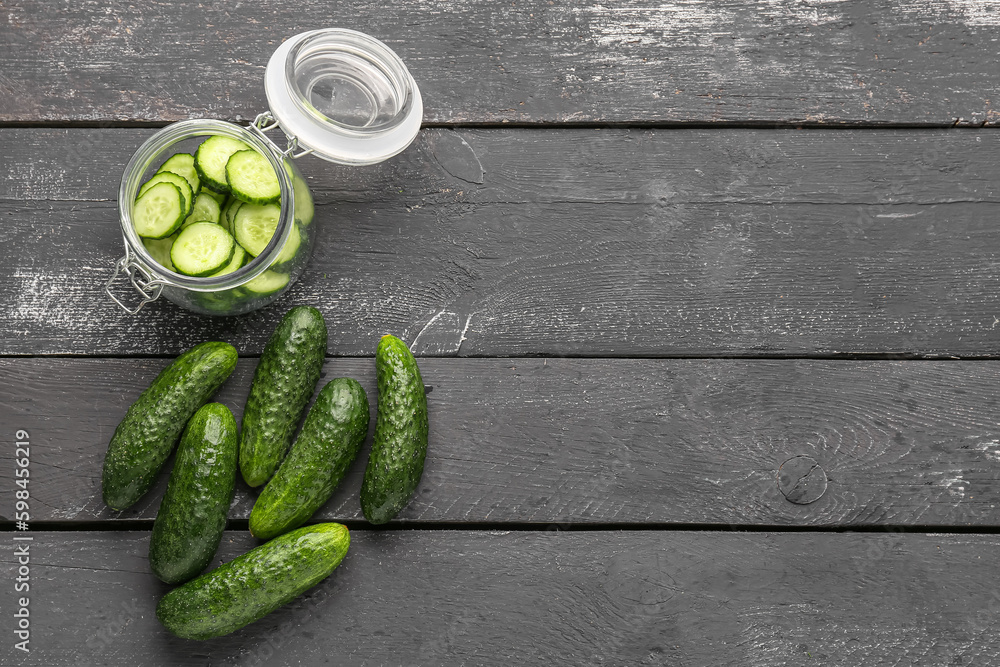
[0,531,1000,667]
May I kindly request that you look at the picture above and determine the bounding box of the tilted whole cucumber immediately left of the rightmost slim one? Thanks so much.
[250,378,369,540]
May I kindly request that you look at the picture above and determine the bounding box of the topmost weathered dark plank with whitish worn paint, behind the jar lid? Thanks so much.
[0,0,1000,125]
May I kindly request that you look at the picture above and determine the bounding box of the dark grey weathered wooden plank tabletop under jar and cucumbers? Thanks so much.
[0,0,1000,667]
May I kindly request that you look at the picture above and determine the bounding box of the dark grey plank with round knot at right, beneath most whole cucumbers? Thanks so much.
[0,358,1000,527]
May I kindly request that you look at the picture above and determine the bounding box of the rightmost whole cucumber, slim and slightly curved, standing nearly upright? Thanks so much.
[361,336,427,524]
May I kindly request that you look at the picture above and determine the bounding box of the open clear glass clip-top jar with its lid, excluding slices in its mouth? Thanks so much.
[105,29,423,315]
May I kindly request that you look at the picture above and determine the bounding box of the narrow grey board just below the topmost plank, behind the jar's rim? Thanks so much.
[7,127,1000,208]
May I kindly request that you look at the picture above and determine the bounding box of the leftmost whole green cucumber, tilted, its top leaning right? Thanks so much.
[101,342,236,510]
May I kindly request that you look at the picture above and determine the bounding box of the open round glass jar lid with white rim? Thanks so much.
[264,28,423,165]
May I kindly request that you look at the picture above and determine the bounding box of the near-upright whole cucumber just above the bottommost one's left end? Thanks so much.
[149,403,238,584]
